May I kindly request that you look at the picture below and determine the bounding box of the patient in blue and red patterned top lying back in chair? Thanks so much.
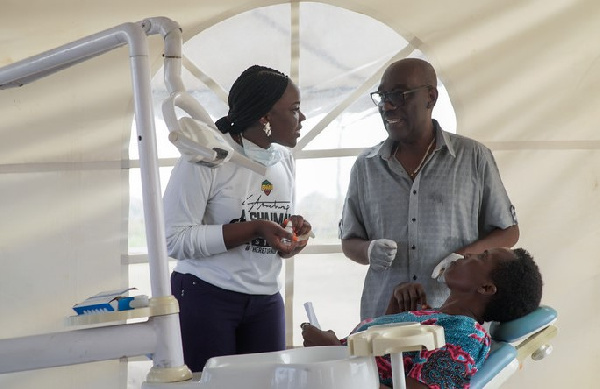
[301,248,542,389]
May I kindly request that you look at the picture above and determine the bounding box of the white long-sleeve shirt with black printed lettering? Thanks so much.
[164,142,295,295]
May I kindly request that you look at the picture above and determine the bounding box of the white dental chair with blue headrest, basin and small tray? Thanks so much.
[142,305,557,389]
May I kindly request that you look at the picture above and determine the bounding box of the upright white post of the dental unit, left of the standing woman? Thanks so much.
[129,18,191,381]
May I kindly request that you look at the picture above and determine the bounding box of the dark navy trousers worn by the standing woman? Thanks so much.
[171,272,285,372]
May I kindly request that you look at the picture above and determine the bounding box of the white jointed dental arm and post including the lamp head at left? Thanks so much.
[0,17,278,382]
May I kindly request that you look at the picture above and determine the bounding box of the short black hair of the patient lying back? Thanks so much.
[483,248,542,322]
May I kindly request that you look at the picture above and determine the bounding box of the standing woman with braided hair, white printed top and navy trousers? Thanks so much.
[164,65,311,372]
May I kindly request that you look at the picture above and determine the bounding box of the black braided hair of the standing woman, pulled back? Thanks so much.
[215,65,289,134]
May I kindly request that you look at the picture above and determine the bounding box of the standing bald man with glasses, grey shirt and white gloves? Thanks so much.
[340,58,519,319]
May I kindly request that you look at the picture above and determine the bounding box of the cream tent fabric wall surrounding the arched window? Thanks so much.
[0,0,600,389]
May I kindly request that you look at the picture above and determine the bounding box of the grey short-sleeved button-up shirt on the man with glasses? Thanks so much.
[340,120,517,320]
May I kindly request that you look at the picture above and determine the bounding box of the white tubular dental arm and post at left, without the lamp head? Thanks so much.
[0,17,191,382]
